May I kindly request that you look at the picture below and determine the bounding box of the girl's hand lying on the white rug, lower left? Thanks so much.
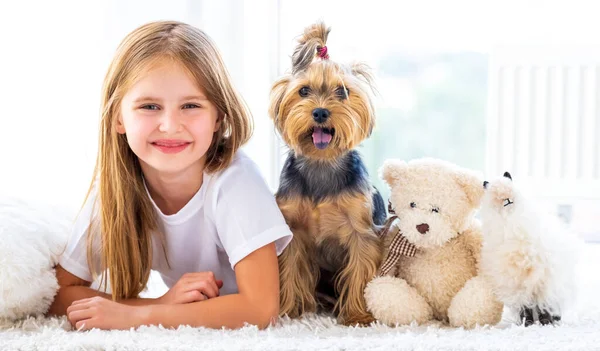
[67,296,146,330]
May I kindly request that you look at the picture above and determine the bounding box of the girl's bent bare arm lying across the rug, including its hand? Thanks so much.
[67,243,279,330]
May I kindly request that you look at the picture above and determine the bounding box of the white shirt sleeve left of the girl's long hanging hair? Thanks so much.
[58,188,100,282]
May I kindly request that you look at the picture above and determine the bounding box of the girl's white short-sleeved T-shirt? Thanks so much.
[59,151,292,295]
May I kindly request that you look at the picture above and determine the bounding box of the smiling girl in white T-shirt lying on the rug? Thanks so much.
[50,22,292,329]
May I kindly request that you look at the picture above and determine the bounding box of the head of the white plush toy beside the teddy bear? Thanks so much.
[481,172,521,221]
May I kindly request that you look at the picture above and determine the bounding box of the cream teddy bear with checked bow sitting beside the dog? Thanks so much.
[365,158,503,328]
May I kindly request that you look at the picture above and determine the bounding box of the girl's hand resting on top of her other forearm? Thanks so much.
[157,272,223,305]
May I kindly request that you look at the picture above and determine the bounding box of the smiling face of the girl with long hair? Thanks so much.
[116,60,220,179]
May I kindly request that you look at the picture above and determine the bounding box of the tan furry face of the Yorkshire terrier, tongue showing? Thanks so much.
[269,60,375,160]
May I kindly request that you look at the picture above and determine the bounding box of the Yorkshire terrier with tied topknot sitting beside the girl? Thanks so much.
[269,23,386,325]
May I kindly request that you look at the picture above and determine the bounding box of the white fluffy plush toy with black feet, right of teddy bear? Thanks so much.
[481,172,580,326]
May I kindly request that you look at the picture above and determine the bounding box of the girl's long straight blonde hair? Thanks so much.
[86,21,252,300]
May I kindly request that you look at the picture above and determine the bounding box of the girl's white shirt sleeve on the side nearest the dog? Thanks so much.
[214,157,292,268]
